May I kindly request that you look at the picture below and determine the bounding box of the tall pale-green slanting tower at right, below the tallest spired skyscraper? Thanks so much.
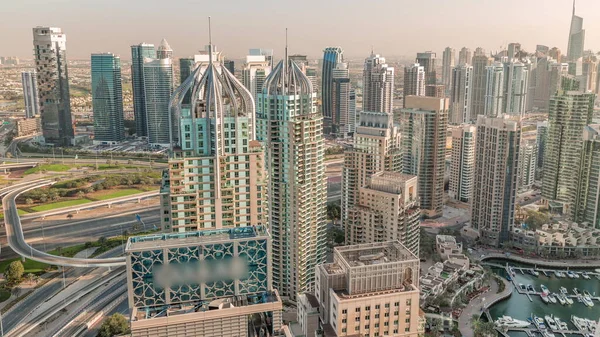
[542,88,595,214]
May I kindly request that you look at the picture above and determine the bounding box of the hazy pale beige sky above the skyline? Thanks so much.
[0,0,600,60]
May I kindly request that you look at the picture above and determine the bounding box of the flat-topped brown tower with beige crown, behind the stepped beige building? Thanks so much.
[400,96,450,218]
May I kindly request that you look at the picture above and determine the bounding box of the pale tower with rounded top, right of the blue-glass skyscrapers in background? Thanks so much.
[363,53,394,112]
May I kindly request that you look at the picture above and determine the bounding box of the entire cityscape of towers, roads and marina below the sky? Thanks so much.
[0,3,600,337]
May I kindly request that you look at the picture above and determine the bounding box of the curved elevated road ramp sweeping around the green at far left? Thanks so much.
[2,180,125,268]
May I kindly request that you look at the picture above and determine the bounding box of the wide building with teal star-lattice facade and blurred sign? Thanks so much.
[125,225,284,337]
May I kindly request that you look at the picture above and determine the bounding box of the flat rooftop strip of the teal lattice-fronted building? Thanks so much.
[125,226,269,251]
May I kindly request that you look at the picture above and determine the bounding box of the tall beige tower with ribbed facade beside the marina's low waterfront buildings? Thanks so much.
[471,115,521,246]
